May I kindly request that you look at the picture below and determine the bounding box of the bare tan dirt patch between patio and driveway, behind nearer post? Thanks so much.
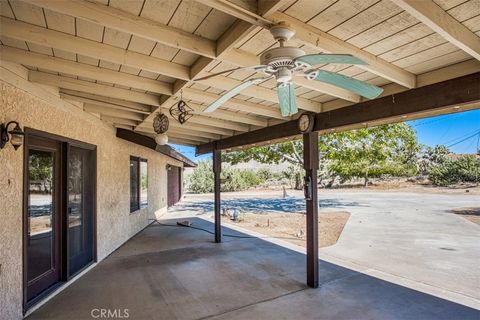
[224,211,350,247]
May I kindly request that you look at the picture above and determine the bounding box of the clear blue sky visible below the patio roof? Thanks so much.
[172,110,480,161]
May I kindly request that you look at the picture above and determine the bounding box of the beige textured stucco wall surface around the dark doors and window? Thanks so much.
[0,74,181,319]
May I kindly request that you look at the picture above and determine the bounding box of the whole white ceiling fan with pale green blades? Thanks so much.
[196,22,383,117]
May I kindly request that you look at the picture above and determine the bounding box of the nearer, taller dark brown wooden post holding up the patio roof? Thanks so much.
[303,132,318,288]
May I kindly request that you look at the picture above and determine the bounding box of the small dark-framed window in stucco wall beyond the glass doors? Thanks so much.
[130,157,148,212]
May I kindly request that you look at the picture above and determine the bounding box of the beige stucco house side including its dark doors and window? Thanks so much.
[0,67,195,319]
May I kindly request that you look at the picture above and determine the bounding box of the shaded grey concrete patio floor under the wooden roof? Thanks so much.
[28,218,480,320]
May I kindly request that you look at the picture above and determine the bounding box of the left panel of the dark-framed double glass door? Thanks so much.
[25,137,61,301]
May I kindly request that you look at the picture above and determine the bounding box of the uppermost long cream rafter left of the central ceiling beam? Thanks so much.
[25,0,216,58]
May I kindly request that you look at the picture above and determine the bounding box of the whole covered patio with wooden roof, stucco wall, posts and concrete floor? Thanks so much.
[0,0,480,319]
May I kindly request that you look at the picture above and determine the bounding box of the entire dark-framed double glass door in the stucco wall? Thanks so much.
[23,128,96,310]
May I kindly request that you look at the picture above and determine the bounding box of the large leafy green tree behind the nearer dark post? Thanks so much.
[223,123,419,188]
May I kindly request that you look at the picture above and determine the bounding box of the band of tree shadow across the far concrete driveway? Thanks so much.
[171,197,366,214]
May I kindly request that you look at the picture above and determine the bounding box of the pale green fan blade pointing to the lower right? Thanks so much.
[305,70,383,99]
